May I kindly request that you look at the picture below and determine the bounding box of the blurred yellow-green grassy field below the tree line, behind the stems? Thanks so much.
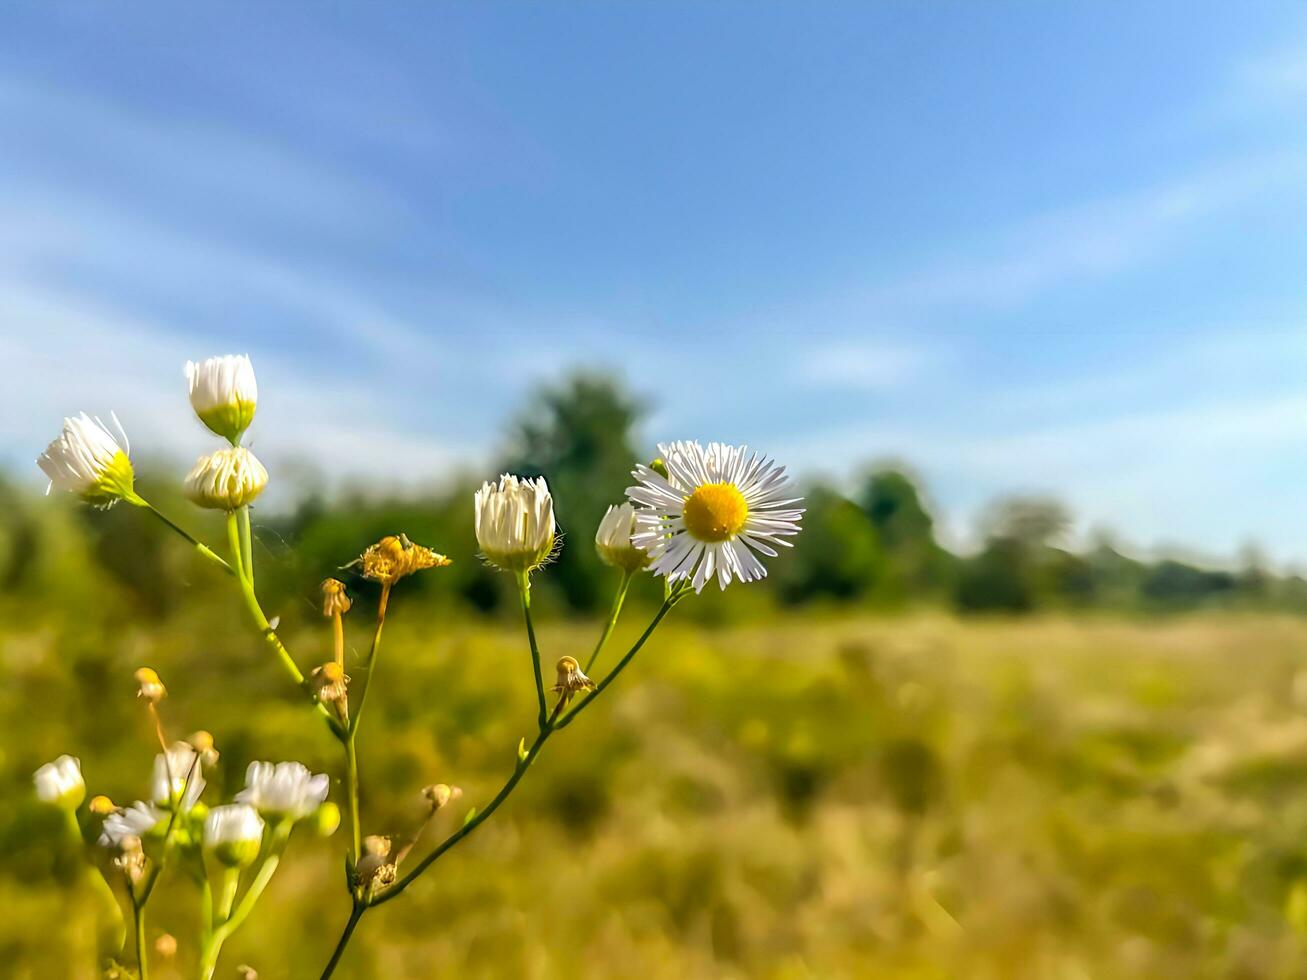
[12,596,1307,977]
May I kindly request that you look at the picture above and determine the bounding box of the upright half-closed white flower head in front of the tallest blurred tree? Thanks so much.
[474,473,554,572]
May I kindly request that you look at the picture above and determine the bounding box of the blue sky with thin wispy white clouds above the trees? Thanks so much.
[0,0,1307,563]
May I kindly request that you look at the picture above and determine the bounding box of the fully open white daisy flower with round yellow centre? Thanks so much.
[626,442,804,592]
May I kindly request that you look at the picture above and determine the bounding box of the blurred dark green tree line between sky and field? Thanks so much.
[0,374,1307,618]
